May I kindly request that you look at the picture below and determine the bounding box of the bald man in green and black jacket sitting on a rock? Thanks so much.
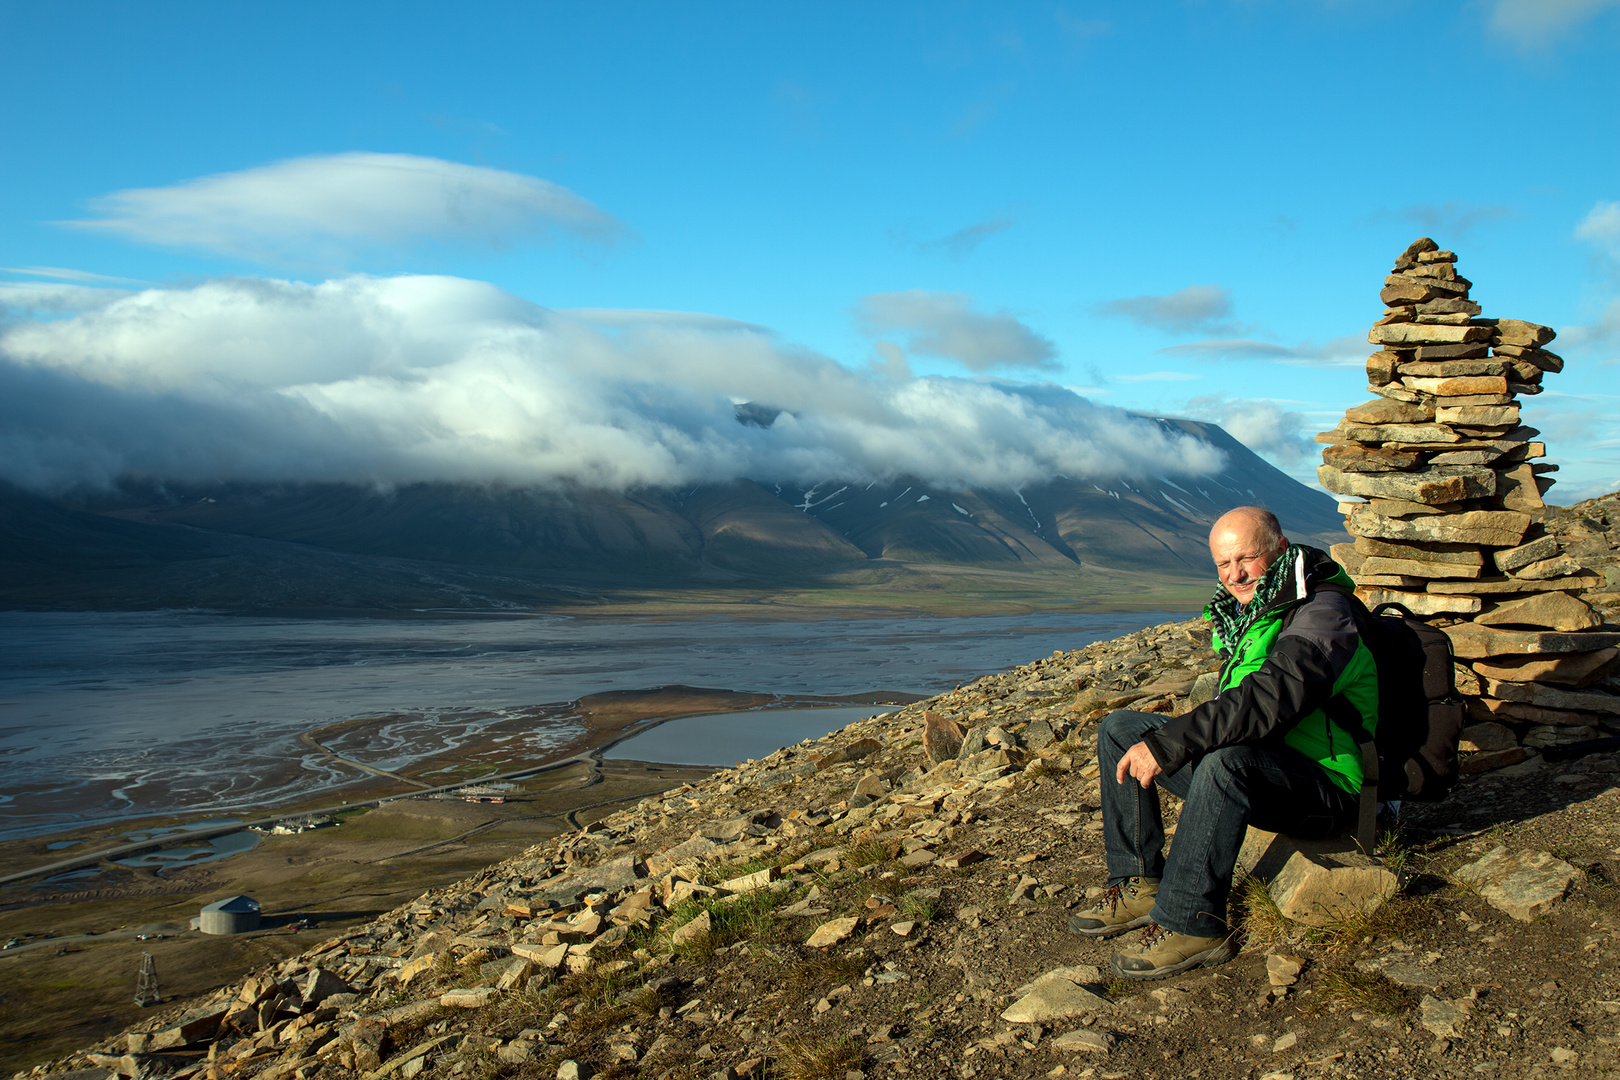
[1069,507,1379,980]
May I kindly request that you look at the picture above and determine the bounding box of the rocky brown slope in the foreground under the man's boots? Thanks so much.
[19,497,1620,1080]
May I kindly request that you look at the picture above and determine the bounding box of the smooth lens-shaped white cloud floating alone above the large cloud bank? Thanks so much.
[63,152,624,264]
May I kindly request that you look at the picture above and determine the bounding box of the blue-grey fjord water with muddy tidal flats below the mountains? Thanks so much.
[0,612,1175,837]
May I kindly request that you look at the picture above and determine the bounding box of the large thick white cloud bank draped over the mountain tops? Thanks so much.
[0,277,1223,491]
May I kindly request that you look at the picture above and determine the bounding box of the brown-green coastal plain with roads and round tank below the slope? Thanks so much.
[0,687,915,1069]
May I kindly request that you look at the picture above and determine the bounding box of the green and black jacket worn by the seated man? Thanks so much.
[1144,546,1379,793]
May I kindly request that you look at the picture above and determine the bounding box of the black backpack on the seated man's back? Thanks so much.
[1296,585,1468,852]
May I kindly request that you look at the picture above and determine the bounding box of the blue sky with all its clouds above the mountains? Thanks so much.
[0,0,1620,500]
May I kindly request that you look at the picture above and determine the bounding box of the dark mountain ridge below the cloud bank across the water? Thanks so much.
[0,419,1340,607]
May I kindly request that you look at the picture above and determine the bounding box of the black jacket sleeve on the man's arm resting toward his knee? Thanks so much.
[1142,591,1361,772]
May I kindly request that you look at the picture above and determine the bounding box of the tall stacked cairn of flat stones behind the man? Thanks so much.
[1317,236,1620,772]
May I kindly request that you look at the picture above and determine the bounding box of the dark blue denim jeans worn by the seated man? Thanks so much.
[1097,711,1358,938]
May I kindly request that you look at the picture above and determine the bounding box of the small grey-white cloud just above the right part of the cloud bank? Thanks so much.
[855,288,1058,371]
